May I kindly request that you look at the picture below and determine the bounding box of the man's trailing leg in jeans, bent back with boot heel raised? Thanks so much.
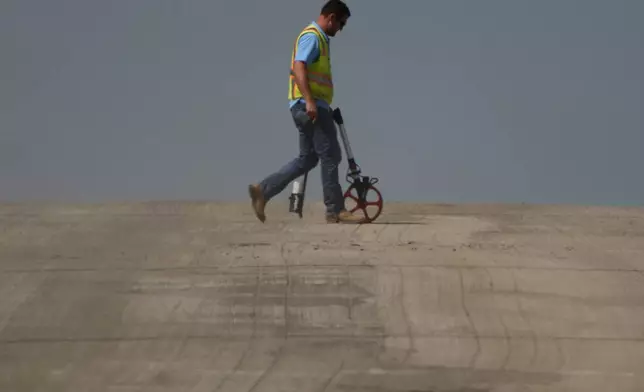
[249,104,318,222]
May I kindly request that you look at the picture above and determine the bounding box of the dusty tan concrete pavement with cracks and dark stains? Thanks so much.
[0,202,644,392]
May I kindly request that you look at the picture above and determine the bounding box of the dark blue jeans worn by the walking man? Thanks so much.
[260,103,344,214]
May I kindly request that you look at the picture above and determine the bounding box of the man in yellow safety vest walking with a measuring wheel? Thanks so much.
[248,0,363,223]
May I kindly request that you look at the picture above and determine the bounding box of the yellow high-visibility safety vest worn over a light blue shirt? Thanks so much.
[288,24,333,105]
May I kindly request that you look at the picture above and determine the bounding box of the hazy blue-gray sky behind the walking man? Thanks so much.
[0,0,644,208]
